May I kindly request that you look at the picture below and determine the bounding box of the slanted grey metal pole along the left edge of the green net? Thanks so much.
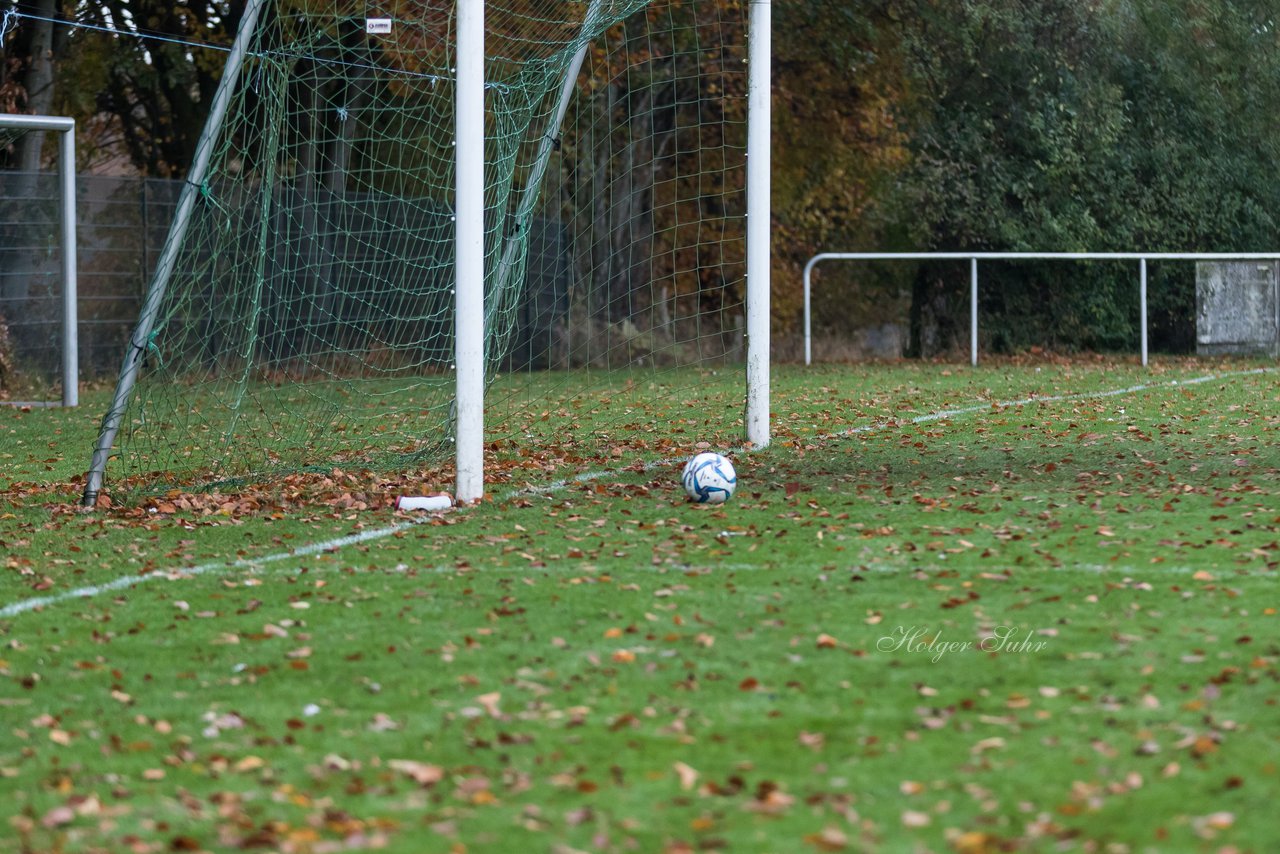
[81,0,270,507]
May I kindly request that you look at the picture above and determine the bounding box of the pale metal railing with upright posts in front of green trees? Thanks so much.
[804,252,1280,365]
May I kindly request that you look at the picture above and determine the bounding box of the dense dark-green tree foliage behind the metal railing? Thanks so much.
[883,0,1280,355]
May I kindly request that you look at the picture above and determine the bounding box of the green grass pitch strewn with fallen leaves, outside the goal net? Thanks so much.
[0,360,1280,853]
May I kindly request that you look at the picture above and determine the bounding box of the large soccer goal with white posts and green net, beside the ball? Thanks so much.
[84,0,769,506]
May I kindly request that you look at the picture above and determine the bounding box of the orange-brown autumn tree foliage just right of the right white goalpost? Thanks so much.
[773,0,909,348]
